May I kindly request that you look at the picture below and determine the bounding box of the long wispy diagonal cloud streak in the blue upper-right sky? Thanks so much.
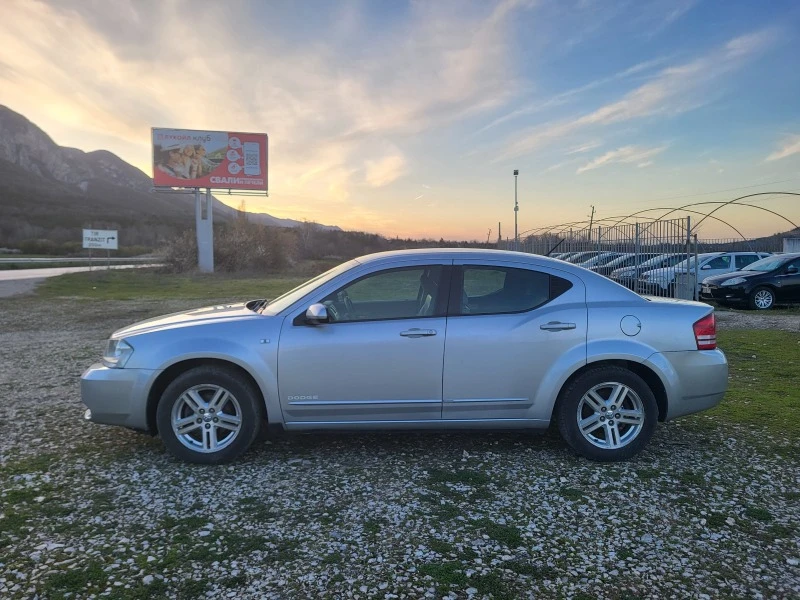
[493,29,776,162]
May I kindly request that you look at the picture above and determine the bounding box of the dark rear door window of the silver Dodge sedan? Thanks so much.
[450,265,572,315]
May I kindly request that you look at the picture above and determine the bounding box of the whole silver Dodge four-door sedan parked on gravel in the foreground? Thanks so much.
[81,249,728,463]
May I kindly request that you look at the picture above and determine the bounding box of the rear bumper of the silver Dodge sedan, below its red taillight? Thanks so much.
[645,350,728,421]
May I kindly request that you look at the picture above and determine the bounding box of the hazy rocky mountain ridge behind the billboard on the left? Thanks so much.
[0,105,339,253]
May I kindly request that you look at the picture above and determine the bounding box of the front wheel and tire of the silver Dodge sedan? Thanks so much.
[156,366,263,464]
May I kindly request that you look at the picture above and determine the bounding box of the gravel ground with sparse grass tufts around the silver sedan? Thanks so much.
[0,298,800,599]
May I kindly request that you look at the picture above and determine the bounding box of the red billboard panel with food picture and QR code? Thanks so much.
[153,128,267,191]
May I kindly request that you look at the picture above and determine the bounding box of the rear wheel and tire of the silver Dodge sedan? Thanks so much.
[556,366,658,462]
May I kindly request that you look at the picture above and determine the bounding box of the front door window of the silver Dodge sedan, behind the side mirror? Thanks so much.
[322,265,443,323]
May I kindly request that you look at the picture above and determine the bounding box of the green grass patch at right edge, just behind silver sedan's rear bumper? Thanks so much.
[704,329,800,439]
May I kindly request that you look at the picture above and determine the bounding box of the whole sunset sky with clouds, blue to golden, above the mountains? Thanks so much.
[0,0,800,239]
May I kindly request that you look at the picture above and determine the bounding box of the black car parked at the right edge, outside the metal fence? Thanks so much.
[700,252,800,310]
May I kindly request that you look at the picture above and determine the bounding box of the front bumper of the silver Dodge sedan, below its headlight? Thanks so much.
[81,363,161,430]
